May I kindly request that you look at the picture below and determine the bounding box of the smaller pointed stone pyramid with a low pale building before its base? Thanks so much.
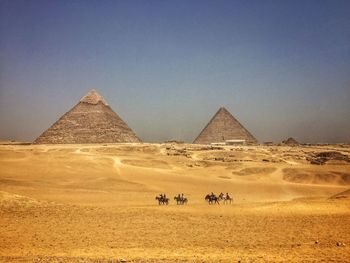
[193,107,257,144]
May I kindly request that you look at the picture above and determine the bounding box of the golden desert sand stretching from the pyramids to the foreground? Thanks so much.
[0,144,350,262]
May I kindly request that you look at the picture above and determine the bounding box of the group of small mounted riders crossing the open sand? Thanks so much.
[156,192,233,205]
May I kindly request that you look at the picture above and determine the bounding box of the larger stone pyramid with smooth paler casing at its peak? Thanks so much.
[34,90,140,144]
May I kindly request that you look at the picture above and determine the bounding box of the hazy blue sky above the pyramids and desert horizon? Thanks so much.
[0,0,350,142]
